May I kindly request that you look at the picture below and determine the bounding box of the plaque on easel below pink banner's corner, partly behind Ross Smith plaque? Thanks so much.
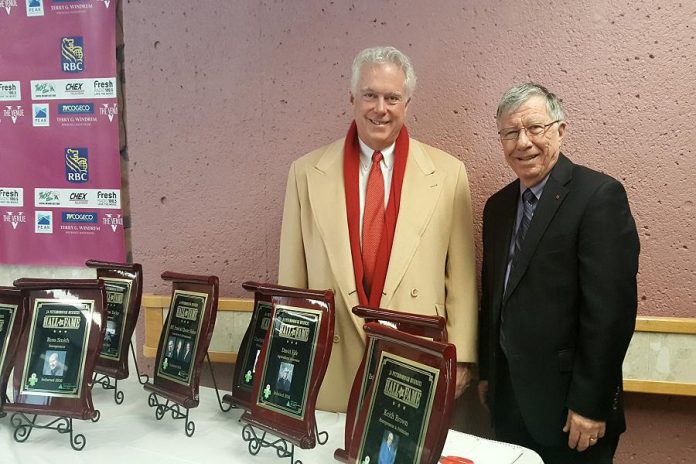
[85,260,148,404]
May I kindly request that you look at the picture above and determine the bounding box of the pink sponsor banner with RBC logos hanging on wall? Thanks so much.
[0,0,125,265]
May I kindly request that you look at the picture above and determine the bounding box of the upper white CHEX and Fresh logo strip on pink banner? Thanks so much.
[31,77,116,100]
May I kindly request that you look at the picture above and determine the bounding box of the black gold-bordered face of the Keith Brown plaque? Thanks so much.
[358,351,440,464]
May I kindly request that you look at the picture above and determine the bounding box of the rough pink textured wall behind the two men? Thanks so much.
[123,0,696,463]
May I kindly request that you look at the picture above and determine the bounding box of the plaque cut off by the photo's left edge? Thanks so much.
[0,287,24,417]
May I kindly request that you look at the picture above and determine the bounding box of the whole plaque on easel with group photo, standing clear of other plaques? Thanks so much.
[145,272,219,437]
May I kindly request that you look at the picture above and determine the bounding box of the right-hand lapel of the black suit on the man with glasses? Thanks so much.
[503,154,573,303]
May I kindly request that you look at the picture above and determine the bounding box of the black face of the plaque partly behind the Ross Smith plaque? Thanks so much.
[100,278,133,361]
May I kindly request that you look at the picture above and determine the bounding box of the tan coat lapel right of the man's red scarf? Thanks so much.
[380,139,444,308]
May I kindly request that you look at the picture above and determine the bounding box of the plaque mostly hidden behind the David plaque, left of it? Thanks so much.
[223,283,273,410]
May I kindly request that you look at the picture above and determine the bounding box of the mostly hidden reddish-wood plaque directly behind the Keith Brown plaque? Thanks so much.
[334,306,447,462]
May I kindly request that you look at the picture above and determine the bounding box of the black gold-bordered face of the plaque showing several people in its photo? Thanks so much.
[157,290,208,385]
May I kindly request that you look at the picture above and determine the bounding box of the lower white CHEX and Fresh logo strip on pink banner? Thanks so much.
[34,188,121,209]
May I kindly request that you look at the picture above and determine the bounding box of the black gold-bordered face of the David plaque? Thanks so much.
[257,305,322,419]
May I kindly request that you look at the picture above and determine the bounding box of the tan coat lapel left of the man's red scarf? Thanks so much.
[307,139,358,310]
